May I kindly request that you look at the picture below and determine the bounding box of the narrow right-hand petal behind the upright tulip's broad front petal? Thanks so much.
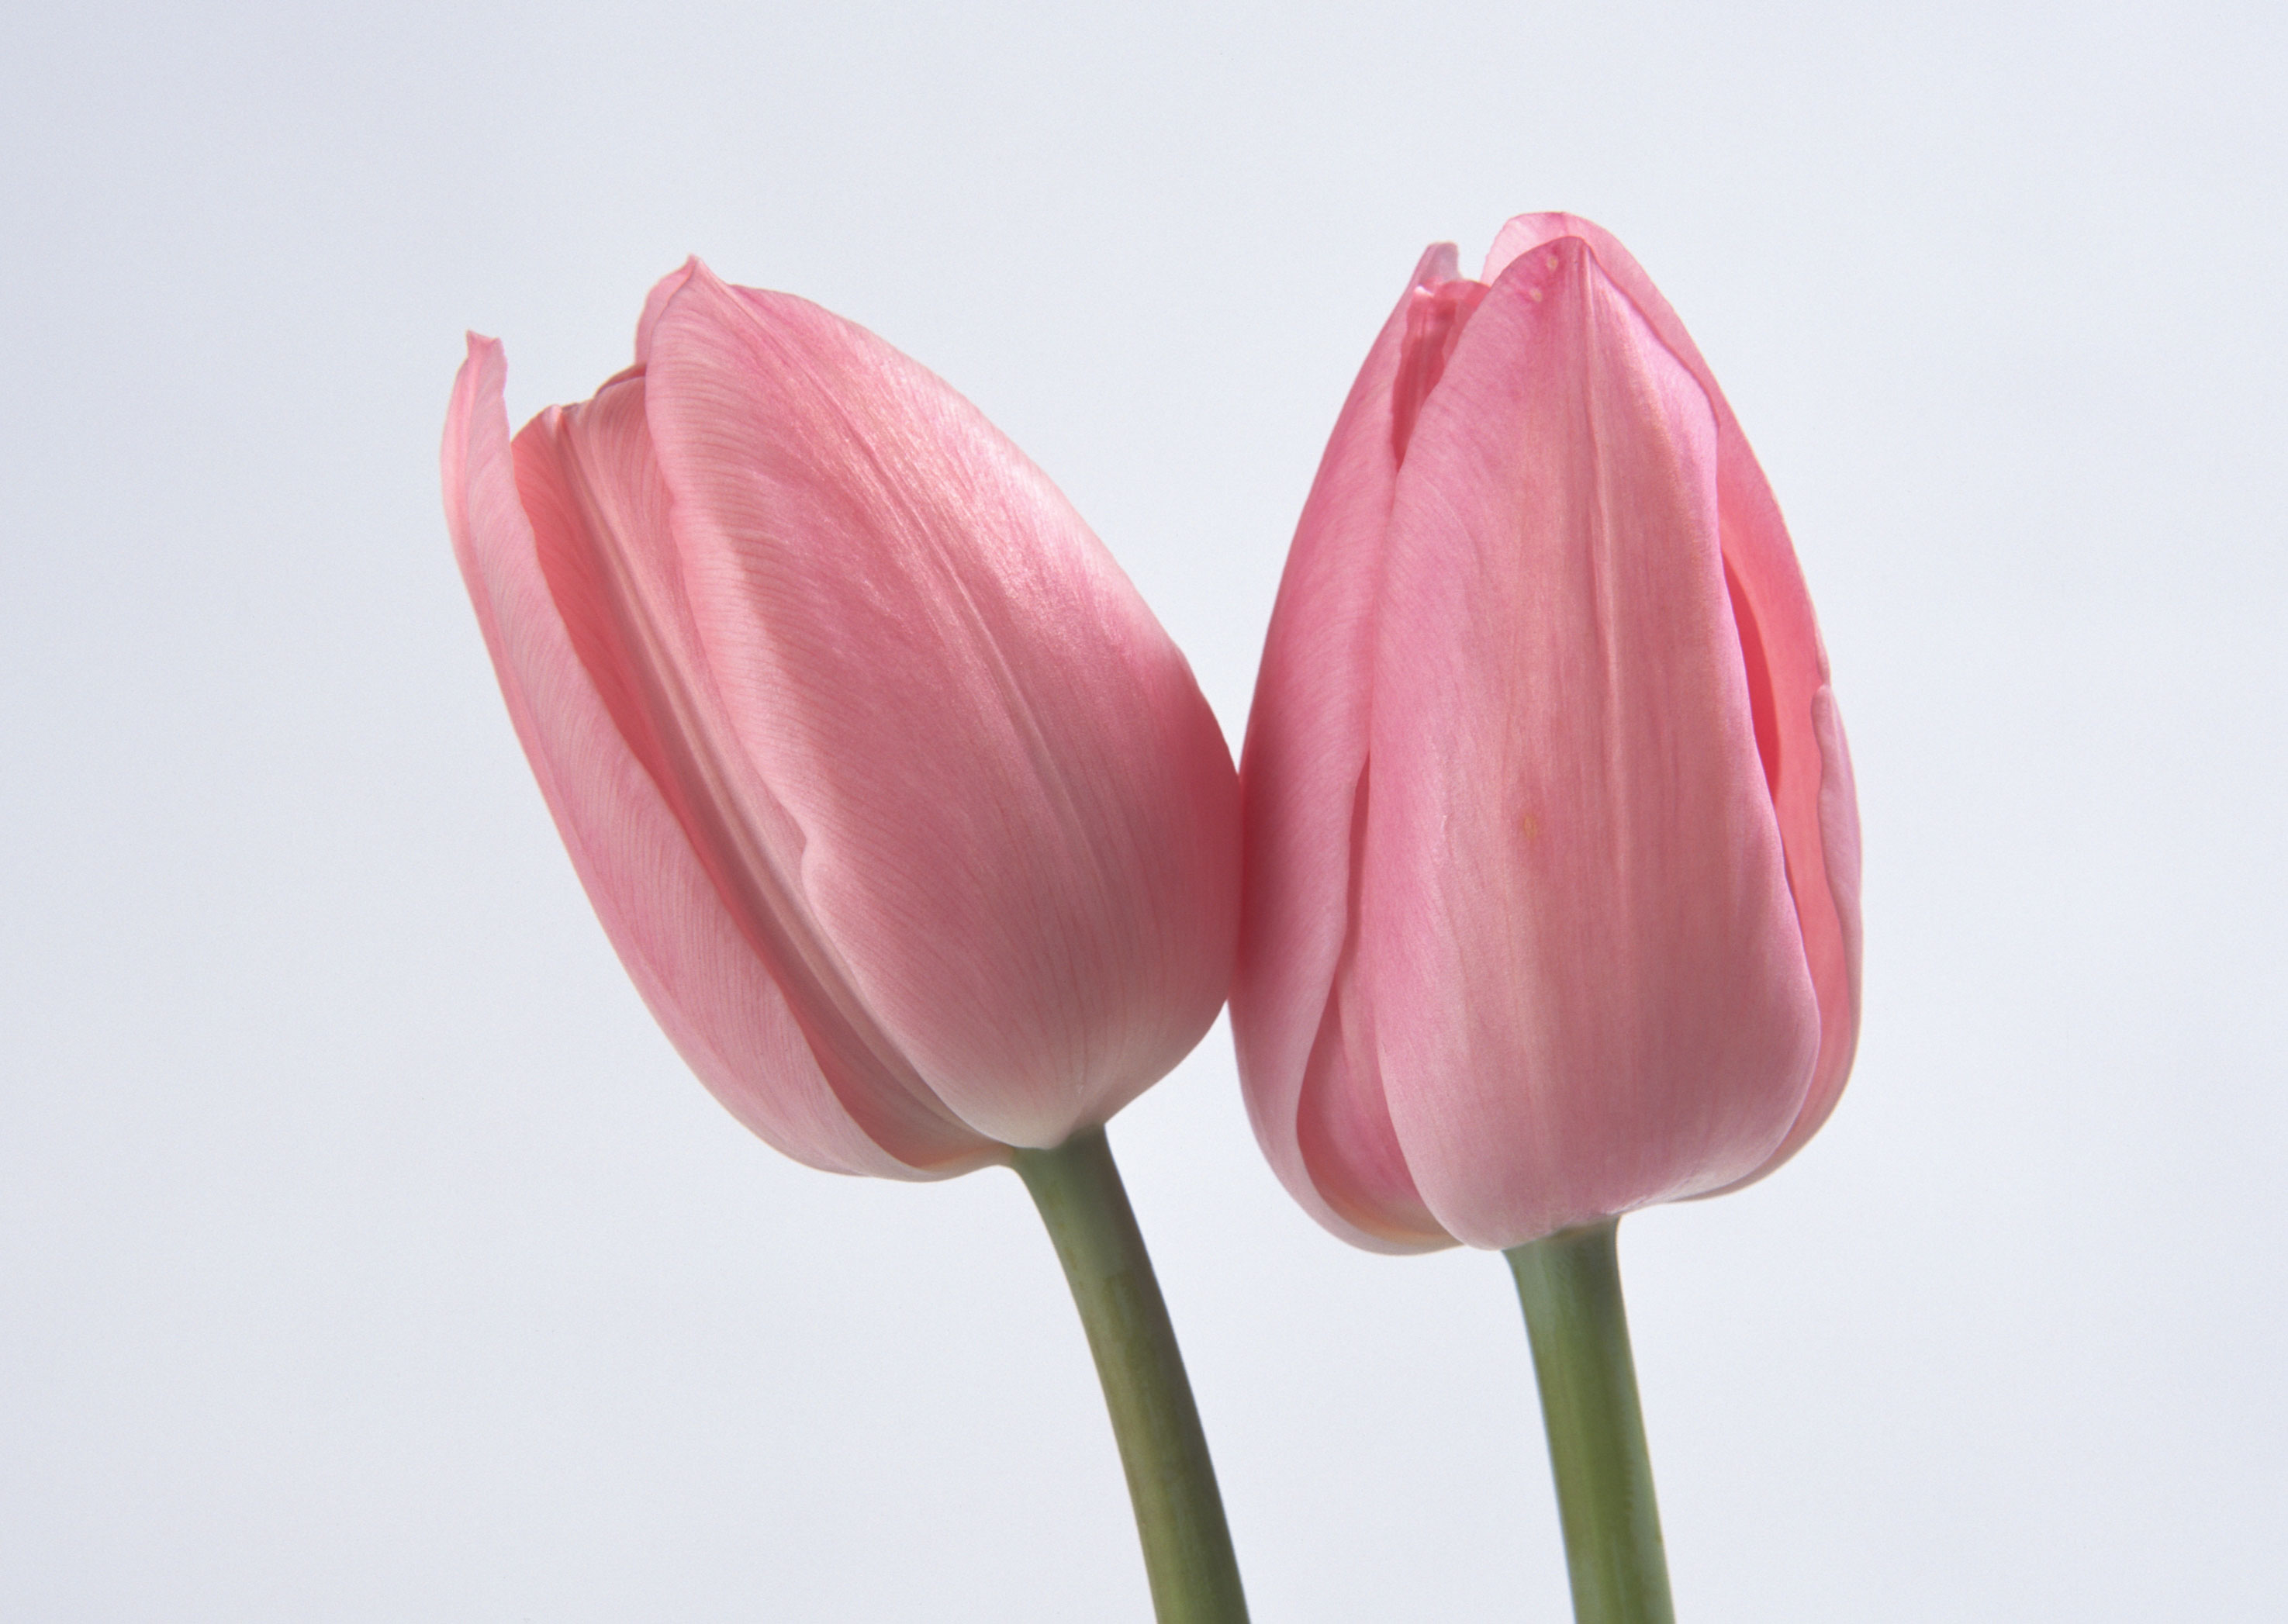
[1485,213,1860,1194]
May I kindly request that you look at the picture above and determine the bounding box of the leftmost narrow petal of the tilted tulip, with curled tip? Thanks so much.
[441,334,997,1178]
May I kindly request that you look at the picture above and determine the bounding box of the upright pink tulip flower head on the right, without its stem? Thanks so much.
[1231,215,1860,1251]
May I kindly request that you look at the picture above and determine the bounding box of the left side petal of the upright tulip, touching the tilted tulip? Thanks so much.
[1231,243,1455,1251]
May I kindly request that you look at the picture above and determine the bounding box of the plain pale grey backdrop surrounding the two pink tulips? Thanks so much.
[0,0,2288,1624]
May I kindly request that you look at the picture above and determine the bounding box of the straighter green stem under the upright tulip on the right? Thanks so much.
[1503,1219,1677,1624]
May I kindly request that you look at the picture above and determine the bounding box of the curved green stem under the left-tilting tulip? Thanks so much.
[1014,1128,1247,1624]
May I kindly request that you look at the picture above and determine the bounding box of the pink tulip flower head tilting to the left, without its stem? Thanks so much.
[444,261,1238,1178]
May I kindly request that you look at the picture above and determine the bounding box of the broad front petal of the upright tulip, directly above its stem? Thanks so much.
[1361,240,1819,1246]
